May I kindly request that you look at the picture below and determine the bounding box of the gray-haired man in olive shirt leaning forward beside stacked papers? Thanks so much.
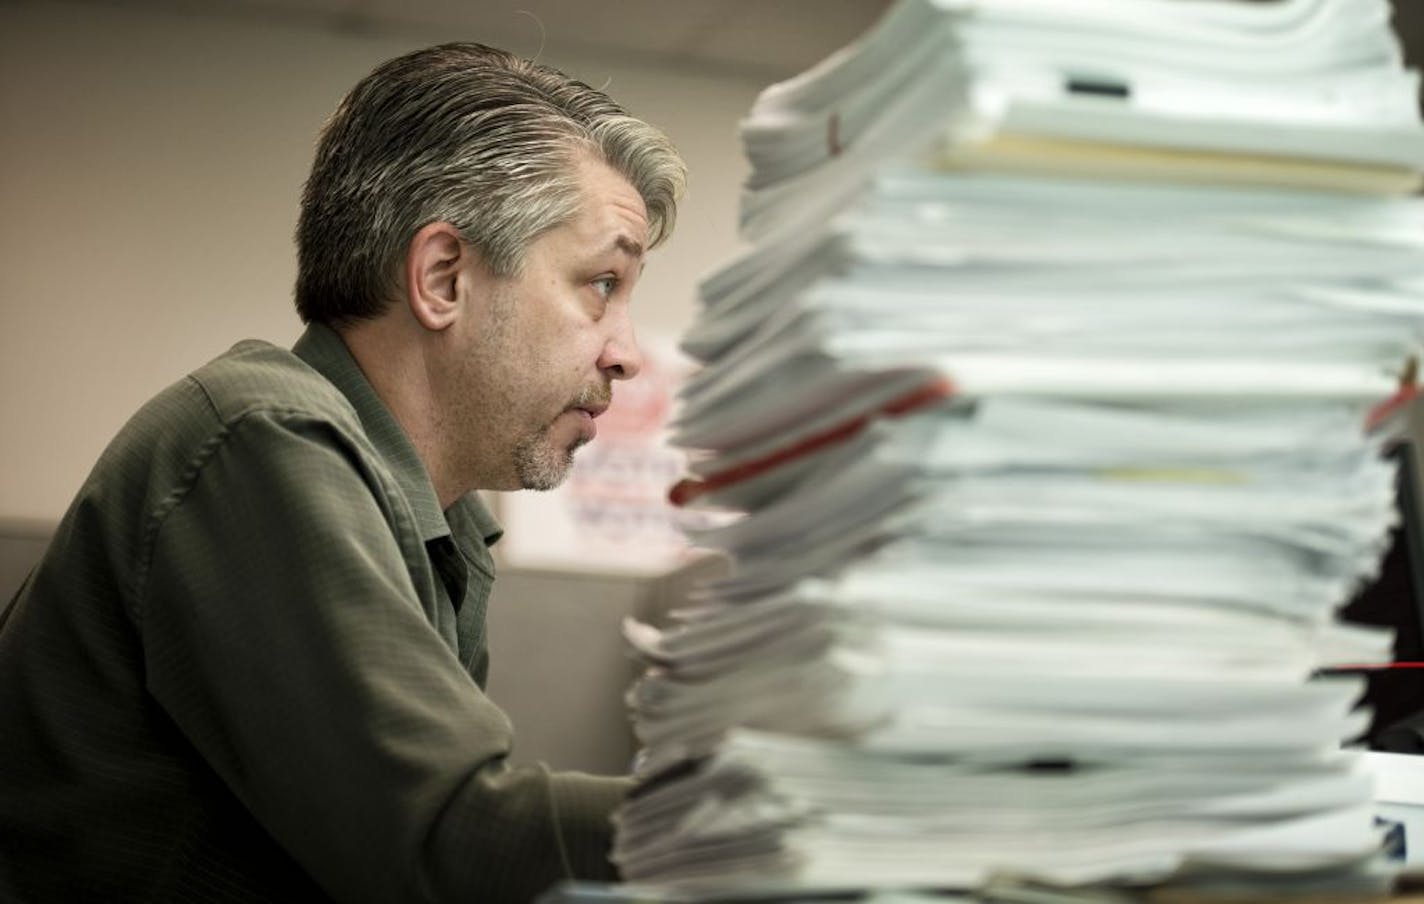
[0,38,684,903]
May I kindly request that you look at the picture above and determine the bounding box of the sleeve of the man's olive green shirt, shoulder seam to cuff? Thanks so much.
[135,411,628,903]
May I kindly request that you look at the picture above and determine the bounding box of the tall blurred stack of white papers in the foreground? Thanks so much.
[615,0,1424,888]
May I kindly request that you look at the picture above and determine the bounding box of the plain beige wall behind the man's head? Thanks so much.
[0,3,760,518]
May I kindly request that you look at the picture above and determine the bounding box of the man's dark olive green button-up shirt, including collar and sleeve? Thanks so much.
[0,326,627,904]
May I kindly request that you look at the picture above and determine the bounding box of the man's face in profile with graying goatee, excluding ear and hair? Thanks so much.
[447,159,648,490]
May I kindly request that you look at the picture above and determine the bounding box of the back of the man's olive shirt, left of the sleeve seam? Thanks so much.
[0,337,359,900]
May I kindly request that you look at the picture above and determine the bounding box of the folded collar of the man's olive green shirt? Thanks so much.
[292,323,504,545]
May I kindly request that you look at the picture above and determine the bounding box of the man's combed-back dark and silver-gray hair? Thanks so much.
[296,43,686,323]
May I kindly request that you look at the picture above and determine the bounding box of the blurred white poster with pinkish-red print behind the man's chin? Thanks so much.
[494,336,717,575]
